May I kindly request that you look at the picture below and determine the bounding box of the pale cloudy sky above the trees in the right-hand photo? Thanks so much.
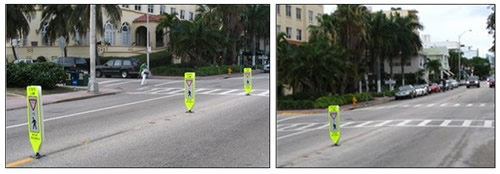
[324,5,493,57]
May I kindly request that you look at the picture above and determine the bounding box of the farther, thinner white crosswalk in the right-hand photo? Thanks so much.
[356,103,495,111]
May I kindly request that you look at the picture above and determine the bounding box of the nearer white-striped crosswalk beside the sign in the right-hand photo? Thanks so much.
[276,119,495,132]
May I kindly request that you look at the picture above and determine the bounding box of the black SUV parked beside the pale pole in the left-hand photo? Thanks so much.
[96,58,140,78]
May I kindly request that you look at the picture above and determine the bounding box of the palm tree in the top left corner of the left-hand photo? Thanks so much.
[5,4,36,60]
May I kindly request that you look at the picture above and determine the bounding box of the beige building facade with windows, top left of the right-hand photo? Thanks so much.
[276,4,324,44]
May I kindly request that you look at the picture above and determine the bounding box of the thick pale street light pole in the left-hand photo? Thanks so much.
[87,5,99,92]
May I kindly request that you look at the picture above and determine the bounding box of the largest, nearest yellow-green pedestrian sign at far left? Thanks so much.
[26,86,44,158]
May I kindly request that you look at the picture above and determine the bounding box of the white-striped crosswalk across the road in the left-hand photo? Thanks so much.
[127,88,269,97]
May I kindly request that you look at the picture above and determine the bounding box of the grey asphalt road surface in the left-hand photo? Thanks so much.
[6,74,270,167]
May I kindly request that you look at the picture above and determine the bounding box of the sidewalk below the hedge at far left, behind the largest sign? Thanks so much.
[6,89,121,111]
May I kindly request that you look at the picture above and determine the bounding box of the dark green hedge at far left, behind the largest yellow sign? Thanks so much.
[7,62,66,89]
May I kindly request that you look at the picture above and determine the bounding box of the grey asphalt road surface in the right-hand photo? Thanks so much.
[277,82,495,167]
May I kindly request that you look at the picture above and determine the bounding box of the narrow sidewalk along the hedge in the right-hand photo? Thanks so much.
[278,97,394,115]
